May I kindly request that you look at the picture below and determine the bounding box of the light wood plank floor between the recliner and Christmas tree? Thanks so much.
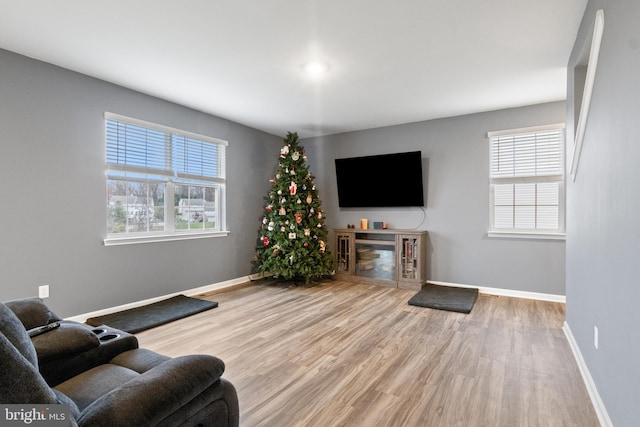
[137,280,599,427]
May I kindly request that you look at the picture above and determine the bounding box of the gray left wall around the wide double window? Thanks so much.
[0,50,282,316]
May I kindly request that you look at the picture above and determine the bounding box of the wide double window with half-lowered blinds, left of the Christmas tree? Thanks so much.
[105,113,227,244]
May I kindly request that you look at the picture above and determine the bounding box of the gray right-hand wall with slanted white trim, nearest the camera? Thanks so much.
[566,0,640,427]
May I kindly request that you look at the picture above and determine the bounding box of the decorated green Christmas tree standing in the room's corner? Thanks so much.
[256,132,333,284]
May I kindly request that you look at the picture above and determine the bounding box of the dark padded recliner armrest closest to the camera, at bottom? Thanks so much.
[78,355,224,427]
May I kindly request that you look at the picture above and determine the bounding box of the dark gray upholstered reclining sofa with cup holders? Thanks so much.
[0,298,239,427]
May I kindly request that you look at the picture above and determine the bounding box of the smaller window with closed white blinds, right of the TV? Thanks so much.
[488,124,564,237]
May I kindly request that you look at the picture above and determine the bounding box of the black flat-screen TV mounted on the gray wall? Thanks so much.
[335,151,424,208]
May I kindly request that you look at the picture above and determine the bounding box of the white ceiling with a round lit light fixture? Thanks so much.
[0,0,587,137]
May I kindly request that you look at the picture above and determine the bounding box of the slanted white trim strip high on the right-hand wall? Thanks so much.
[569,9,604,181]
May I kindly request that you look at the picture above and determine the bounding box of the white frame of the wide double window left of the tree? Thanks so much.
[103,112,229,246]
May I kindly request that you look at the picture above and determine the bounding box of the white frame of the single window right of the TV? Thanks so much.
[487,123,567,240]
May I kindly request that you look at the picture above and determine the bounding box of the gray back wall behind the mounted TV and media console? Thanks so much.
[303,102,566,295]
